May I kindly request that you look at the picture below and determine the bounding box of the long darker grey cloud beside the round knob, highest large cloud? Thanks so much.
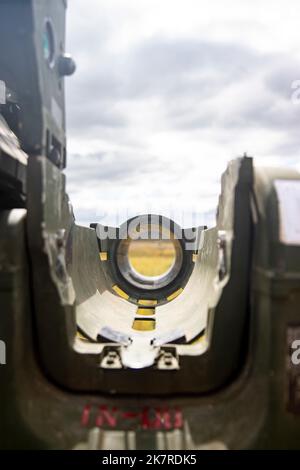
[70,38,266,101]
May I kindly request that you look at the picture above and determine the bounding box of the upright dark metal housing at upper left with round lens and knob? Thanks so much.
[0,0,74,168]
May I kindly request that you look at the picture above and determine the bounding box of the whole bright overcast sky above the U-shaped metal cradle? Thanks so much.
[66,0,300,225]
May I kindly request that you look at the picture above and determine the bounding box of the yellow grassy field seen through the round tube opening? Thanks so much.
[128,240,176,277]
